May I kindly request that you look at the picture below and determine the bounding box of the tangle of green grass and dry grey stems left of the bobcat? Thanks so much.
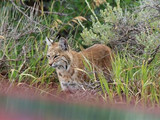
[0,4,54,84]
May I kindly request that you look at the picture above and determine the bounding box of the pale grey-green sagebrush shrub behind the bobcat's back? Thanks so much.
[81,1,160,56]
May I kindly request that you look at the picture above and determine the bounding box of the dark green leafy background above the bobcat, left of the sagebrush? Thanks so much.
[16,0,139,44]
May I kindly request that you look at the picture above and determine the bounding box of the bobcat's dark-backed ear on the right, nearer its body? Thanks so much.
[59,37,69,51]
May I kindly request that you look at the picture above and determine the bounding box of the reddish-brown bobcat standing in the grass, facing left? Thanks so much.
[46,37,113,91]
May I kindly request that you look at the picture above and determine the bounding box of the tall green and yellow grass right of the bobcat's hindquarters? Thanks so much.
[100,51,160,105]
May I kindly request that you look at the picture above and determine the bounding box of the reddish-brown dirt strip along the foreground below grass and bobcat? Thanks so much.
[0,76,159,109]
